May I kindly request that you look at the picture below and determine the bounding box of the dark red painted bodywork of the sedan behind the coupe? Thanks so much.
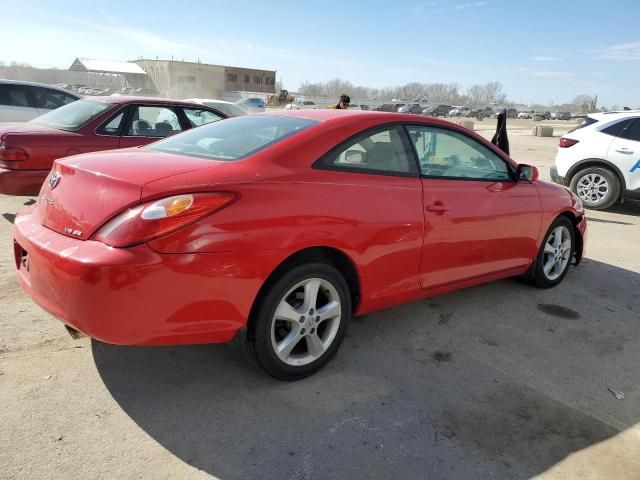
[0,97,221,195]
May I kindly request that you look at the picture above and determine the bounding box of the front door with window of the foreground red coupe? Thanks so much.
[407,125,542,289]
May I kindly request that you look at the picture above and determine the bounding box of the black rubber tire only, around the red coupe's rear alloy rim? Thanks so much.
[246,263,351,381]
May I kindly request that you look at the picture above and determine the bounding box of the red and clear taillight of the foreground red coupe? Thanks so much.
[91,192,237,247]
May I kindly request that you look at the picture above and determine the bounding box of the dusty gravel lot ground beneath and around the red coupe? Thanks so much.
[0,124,640,479]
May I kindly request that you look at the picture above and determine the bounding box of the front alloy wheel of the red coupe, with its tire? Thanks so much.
[533,217,576,288]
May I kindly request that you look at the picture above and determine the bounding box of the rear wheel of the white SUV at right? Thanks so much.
[570,167,620,210]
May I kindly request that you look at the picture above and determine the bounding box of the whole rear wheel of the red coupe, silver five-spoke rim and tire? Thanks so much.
[248,263,351,380]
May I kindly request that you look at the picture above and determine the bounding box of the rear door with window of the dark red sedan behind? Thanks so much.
[120,104,183,148]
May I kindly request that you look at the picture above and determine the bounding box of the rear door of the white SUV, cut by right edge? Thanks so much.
[607,117,640,190]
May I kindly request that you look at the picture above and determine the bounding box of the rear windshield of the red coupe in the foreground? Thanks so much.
[145,115,319,160]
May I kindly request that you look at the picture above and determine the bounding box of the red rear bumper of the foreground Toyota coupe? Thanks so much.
[14,208,264,345]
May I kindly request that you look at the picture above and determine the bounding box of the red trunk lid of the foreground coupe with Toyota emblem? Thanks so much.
[36,148,227,240]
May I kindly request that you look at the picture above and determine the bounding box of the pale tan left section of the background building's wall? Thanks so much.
[135,60,225,99]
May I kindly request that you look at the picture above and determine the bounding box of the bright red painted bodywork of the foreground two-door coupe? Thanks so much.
[14,110,586,344]
